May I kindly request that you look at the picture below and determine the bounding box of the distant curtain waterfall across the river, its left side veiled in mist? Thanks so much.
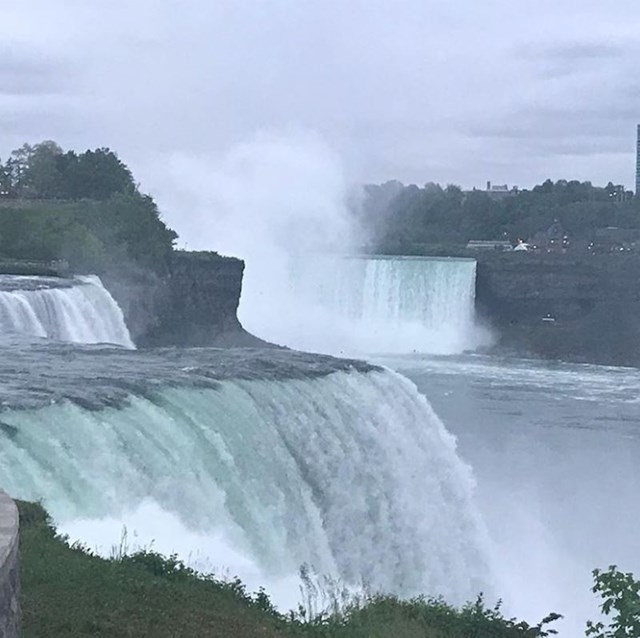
[241,256,486,354]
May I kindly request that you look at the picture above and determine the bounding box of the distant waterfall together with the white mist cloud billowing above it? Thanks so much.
[148,133,488,355]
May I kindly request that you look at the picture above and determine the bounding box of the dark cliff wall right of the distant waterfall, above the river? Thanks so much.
[476,253,640,366]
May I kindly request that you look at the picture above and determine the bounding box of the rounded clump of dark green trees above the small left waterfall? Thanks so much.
[0,141,177,272]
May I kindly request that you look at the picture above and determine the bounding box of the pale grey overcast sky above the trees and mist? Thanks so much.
[0,0,640,192]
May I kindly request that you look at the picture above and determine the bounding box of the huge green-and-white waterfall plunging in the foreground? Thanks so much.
[0,371,491,604]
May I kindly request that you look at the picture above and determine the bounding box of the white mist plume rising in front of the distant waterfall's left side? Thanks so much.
[148,131,362,345]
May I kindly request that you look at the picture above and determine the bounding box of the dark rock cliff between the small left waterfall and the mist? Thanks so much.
[102,251,268,347]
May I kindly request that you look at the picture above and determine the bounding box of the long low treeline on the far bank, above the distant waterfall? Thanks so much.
[360,180,640,252]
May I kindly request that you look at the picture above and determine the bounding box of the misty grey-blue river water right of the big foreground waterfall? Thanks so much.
[383,356,640,636]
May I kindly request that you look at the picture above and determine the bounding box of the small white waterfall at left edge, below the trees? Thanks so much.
[0,275,135,348]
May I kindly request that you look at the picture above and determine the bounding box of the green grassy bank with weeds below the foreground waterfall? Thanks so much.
[18,502,548,638]
